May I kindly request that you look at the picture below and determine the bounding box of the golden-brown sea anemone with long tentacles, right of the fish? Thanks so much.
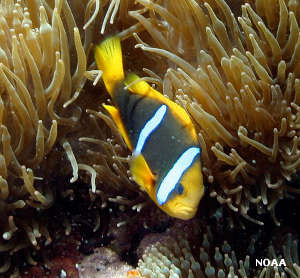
[120,0,300,225]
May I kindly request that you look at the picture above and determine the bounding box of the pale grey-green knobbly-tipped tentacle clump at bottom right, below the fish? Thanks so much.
[137,224,300,278]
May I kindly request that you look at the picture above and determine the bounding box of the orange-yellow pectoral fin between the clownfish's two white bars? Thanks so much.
[130,154,155,193]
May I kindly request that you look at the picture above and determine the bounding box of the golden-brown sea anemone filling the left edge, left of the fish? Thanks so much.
[0,0,97,273]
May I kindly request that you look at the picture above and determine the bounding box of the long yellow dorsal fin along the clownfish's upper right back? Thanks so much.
[124,73,197,140]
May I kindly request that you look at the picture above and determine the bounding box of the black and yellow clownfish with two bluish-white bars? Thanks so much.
[95,36,204,220]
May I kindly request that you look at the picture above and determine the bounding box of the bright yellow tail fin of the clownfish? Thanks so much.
[95,36,124,95]
